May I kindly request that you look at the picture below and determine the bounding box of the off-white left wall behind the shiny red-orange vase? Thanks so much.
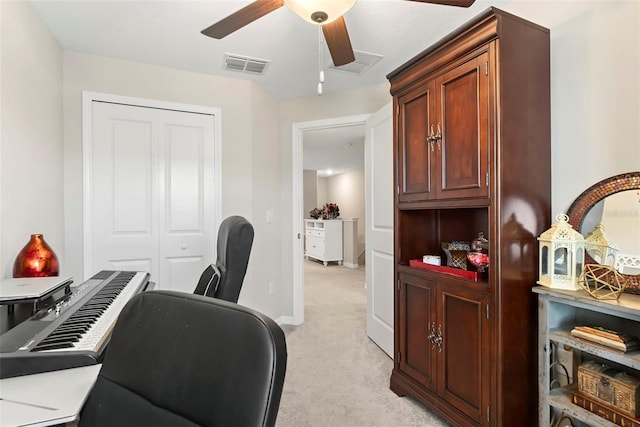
[0,1,63,277]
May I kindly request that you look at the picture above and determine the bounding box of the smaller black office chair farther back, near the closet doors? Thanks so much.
[194,215,253,302]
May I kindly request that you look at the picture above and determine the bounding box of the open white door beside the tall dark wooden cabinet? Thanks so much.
[364,103,393,357]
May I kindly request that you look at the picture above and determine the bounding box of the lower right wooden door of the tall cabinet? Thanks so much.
[438,284,491,425]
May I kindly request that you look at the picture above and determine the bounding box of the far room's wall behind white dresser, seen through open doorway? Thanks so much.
[326,169,365,257]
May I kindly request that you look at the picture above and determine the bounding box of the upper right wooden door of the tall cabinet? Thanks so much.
[430,52,491,199]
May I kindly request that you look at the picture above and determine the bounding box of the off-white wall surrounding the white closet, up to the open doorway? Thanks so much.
[63,52,281,316]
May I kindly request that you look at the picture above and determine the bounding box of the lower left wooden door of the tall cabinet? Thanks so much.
[397,275,436,391]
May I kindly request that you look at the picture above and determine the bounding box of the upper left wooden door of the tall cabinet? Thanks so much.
[396,84,435,202]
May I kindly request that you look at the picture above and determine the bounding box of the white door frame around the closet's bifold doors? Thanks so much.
[82,91,222,280]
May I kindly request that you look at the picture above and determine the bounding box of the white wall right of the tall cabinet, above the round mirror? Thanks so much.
[503,0,640,217]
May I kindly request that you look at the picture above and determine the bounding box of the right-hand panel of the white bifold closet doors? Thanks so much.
[158,110,215,292]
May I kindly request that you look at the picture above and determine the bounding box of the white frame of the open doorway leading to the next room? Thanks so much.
[291,114,371,325]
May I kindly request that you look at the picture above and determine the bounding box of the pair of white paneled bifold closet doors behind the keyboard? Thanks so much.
[85,101,215,292]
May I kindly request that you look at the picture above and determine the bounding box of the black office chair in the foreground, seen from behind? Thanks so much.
[79,291,287,427]
